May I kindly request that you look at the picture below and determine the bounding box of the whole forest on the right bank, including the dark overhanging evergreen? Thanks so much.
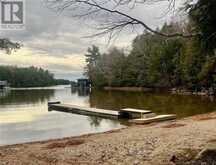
[85,0,216,91]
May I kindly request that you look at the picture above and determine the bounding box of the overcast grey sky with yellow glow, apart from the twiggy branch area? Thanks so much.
[0,0,183,80]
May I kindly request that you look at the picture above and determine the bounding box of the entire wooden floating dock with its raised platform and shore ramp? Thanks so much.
[48,102,177,124]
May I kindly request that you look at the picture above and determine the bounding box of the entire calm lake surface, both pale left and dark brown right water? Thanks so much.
[0,86,216,145]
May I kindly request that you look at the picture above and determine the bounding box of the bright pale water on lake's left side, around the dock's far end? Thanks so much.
[0,88,123,145]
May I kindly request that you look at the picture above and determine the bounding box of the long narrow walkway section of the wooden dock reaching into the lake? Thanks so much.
[48,103,120,118]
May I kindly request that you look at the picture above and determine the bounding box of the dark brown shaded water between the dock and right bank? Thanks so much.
[89,90,216,117]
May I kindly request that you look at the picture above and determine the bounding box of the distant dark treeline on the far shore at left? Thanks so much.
[0,66,70,88]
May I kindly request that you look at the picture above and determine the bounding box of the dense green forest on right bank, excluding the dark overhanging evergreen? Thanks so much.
[86,21,216,90]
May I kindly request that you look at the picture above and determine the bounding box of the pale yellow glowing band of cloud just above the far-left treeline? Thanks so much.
[0,48,85,72]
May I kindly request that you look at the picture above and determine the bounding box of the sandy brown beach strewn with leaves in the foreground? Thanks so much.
[0,112,216,165]
